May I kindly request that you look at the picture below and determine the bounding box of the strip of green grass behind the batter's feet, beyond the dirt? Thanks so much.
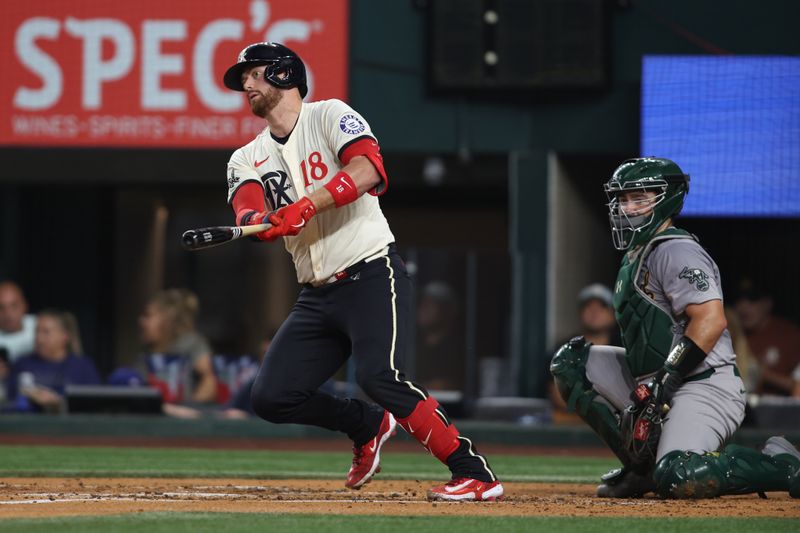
[0,446,617,483]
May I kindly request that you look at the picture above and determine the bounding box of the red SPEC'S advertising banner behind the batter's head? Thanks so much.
[0,0,348,147]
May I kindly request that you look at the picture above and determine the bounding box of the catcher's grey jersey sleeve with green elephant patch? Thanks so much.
[650,239,722,316]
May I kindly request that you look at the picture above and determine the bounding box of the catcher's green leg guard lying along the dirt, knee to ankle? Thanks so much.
[653,444,800,499]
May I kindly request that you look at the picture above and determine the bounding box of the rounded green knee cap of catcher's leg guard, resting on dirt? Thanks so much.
[653,451,725,499]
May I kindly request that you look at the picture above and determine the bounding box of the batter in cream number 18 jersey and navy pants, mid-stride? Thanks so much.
[224,43,503,501]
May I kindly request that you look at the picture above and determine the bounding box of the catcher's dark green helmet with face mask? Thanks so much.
[605,157,689,250]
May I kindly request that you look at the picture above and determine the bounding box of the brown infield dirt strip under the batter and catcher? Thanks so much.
[0,478,800,518]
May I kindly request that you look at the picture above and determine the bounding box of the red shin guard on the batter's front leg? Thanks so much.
[397,396,458,464]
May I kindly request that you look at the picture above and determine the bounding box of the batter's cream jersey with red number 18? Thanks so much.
[228,100,394,285]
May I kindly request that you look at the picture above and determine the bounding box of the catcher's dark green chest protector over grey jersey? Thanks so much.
[614,228,694,377]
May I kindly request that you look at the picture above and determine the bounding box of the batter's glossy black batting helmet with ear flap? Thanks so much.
[223,43,308,98]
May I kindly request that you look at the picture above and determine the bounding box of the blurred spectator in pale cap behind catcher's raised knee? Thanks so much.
[546,283,622,423]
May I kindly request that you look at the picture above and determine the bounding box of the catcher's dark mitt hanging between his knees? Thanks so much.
[620,369,683,474]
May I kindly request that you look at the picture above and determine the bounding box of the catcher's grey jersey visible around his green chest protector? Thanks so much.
[637,233,736,374]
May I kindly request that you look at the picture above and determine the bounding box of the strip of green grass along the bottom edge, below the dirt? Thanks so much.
[0,513,797,533]
